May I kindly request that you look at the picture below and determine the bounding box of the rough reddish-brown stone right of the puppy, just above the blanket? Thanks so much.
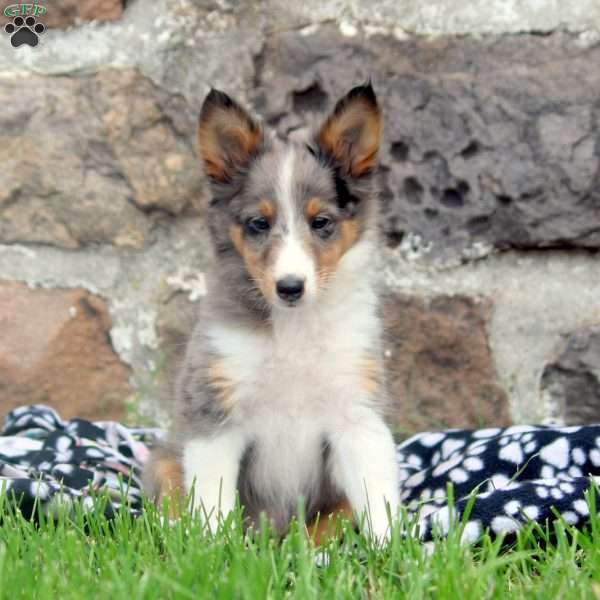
[385,294,510,433]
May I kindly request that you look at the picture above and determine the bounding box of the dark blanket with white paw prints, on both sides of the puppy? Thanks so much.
[0,405,600,542]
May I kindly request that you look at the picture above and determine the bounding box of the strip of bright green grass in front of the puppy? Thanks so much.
[0,490,600,600]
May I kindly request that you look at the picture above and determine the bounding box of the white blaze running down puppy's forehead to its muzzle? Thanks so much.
[273,147,316,300]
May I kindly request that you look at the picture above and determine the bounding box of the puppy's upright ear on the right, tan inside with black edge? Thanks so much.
[317,82,382,177]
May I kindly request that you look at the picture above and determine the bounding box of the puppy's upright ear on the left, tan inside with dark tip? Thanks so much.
[198,89,263,183]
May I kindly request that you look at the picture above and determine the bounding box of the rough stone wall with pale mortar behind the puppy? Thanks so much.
[0,0,600,432]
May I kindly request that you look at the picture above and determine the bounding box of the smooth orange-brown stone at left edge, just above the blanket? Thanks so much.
[0,283,131,419]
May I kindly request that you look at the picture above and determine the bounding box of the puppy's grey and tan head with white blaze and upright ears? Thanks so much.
[198,84,382,312]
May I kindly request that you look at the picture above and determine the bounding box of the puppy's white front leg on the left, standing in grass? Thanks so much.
[183,426,245,533]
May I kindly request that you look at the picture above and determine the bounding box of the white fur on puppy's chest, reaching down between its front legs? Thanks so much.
[204,258,380,505]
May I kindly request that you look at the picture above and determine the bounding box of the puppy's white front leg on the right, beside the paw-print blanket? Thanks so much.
[330,408,400,540]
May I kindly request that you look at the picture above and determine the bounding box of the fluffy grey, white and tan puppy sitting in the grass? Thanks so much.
[146,83,399,538]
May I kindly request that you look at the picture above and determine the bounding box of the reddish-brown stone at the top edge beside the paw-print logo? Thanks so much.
[0,0,123,29]
